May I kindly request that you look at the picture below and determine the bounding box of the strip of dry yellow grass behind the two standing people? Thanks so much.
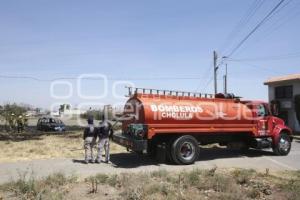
[0,131,125,162]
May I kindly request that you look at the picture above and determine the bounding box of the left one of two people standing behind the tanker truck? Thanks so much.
[83,119,97,164]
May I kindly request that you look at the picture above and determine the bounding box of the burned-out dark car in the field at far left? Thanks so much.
[37,117,66,132]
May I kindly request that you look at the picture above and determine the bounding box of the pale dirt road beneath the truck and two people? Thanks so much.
[0,139,300,183]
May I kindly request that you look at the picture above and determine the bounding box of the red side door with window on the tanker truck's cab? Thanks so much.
[255,104,273,136]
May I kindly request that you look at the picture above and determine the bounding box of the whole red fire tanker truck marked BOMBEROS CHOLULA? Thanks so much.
[113,88,292,164]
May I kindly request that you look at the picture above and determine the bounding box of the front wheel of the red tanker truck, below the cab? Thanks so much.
[273,133,292,156]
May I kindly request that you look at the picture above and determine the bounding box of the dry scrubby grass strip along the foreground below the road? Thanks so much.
[0,169,300,200]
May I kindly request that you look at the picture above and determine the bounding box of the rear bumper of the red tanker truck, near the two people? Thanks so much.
[113,133,148,152]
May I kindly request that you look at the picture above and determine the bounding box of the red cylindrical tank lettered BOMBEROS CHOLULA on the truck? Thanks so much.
[123,94,253,135]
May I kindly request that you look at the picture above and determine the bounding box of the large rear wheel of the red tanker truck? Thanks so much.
[171,135,199,165]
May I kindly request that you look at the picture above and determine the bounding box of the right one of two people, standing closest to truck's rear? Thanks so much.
[96,115,113,163]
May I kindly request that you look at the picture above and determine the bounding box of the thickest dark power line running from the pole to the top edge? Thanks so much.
[228,0,285,57]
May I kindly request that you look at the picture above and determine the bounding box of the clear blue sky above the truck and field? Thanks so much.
[0,0,300,108]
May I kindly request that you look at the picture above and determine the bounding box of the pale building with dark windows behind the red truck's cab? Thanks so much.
[264,74,300,132]
